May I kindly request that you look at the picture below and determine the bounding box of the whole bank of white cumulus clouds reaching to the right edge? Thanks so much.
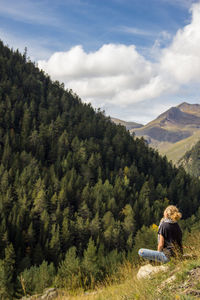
[38,3,200,112]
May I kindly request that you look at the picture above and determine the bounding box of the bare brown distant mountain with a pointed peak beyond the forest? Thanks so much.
[130,102,200,163]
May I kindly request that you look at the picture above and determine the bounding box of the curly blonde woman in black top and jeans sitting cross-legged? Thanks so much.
[138,205,183,263]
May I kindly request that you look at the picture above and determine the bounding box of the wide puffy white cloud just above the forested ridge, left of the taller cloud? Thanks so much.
[38,44,156,105]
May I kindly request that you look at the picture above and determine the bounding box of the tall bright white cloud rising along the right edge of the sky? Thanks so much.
[161,3,200,85]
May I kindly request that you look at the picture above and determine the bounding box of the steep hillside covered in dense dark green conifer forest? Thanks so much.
[0,42,200,299]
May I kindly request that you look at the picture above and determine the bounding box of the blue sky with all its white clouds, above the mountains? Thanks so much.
[0,0,200,123]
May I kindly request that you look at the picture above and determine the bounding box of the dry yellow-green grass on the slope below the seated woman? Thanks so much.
[57,232,200,300]
